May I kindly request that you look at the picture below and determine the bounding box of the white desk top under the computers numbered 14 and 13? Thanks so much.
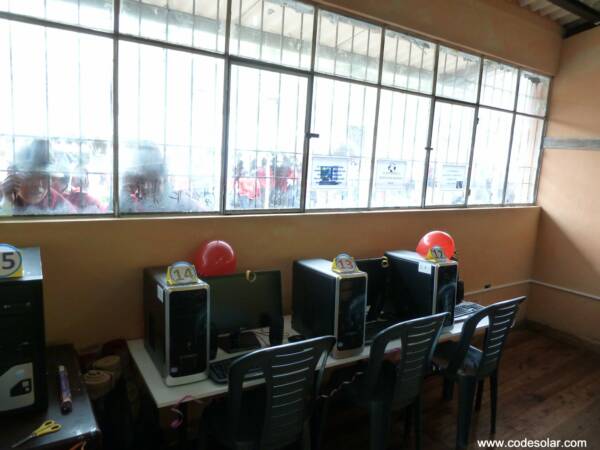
[127,316,488,408]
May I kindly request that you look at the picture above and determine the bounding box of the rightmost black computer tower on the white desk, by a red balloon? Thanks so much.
[385,251,458,326]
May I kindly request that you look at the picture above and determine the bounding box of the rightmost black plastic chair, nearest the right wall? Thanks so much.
[434,297,525,450]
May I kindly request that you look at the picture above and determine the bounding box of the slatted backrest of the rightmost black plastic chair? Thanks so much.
[446,297,526,377]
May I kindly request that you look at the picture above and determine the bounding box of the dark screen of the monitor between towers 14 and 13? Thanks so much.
[202,270,283,333]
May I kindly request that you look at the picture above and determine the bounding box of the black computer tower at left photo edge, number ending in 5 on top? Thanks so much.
[0,247,48,415]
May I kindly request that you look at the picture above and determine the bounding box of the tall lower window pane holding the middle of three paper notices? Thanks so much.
[371,89,431,207]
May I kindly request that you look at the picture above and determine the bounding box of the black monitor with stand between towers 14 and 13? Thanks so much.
[202,270,283,353]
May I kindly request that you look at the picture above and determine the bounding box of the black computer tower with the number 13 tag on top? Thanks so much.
[292,259,367,358]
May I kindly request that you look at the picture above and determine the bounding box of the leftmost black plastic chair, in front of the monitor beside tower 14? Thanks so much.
[206,336,335,450]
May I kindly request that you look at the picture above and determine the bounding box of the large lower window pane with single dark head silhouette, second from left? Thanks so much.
[119,42,223,213]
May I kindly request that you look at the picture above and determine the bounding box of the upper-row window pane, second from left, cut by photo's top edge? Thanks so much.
[119,0,227,52]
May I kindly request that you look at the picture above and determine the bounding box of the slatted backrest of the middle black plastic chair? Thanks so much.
[365,313,448,406]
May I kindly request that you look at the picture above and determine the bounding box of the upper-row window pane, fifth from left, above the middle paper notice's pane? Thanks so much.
[381,30,435,94]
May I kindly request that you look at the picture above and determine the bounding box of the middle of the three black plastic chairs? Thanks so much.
[351,313,448,450]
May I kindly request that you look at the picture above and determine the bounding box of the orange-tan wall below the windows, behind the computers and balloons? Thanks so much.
[0,207,539,347]
